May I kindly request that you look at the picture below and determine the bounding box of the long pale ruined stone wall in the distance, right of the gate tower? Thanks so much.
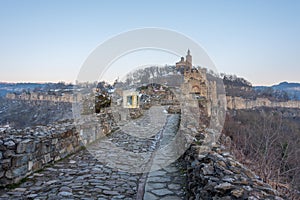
[226,96,300,109]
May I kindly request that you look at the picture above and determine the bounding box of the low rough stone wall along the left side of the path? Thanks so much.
[0,113,112,186]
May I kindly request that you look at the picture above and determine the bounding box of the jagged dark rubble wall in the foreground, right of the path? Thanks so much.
[185,146,282,200]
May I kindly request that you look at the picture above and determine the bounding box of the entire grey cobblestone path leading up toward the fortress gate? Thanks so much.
[0,107,185,200]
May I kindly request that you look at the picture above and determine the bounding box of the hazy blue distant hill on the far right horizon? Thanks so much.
[254,82,300,100]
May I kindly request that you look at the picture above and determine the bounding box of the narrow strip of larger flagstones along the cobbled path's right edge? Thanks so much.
[144,112,186,200]
